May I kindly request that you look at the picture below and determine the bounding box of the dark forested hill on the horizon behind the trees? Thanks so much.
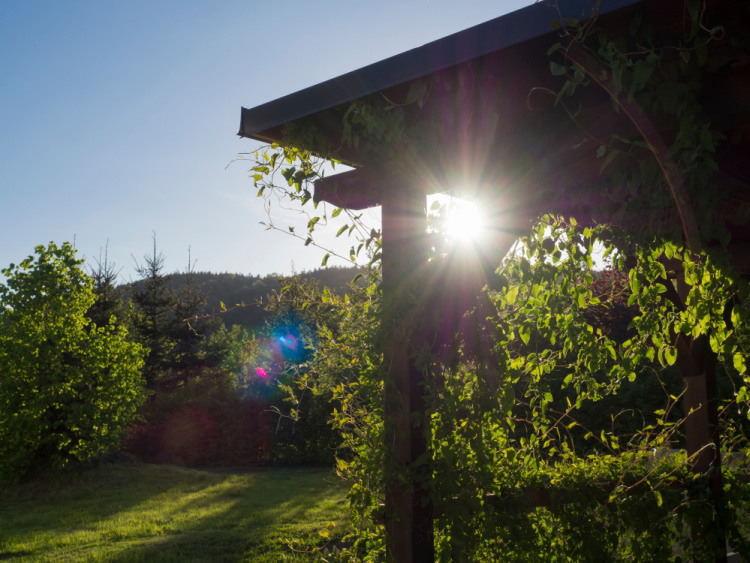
[128,266,359,330]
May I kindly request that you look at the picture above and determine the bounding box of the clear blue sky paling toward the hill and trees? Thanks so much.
[0,0,533,280]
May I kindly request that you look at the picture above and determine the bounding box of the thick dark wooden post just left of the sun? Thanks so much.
[382,190,434,563]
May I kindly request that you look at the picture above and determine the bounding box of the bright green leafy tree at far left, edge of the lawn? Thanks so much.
[0,243,143,480]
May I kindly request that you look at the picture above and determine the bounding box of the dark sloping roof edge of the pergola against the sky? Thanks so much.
[237,0,642,142]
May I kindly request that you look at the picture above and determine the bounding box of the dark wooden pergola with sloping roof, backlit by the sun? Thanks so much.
[239,0,750,561]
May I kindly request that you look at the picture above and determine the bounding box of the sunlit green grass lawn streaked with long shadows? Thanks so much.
[0,463,346,562]
